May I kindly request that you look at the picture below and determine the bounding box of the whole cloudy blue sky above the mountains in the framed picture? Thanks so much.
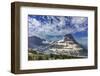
[28,15,88,48]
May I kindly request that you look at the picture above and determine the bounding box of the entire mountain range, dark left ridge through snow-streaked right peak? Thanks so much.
[28,34,87,56]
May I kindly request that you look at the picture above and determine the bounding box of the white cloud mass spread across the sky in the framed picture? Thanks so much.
[28,16,87,39]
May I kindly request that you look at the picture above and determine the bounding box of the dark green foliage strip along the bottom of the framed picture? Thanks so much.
[28,50,82,60]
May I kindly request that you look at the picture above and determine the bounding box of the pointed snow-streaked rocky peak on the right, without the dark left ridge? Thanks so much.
[45,34,84,56]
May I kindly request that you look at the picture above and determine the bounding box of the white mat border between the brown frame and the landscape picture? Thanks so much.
[20,7,94,70]
